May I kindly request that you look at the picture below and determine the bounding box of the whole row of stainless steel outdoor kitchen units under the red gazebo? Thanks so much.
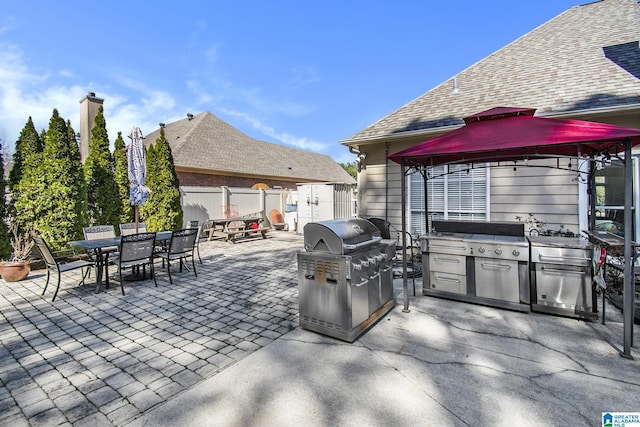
[420,220,598,319]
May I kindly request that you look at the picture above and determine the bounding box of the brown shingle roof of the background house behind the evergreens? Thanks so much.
[145,111,355,184]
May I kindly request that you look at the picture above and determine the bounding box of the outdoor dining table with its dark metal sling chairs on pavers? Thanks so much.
[32,222,202,302]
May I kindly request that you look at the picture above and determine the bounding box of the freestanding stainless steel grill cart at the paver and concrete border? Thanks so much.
[298,218,395,342]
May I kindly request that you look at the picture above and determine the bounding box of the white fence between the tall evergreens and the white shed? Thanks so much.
[180,186,296,224]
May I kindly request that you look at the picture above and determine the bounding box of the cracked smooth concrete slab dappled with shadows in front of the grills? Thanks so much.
[130,280,640,427]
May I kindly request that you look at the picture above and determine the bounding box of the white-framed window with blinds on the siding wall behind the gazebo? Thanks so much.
[409,165,489,235]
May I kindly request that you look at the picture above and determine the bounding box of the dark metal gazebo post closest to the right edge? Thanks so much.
[622,138,635,359]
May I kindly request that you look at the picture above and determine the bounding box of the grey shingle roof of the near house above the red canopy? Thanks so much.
[341,0,640,145]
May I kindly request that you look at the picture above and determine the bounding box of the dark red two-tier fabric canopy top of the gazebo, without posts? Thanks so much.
[388,107,640,167]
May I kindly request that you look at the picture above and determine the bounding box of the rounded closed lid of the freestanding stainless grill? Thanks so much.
[304,218,382,255]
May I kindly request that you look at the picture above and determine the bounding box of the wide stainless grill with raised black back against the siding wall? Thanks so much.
[421,221,530,311]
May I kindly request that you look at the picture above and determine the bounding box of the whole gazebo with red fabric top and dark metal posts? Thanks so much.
[387,107,640,358]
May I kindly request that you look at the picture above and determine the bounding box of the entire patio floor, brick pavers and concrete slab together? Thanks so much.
[0,232,640,427]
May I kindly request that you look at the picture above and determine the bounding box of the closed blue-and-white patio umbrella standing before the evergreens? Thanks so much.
[127,127,151,233]
